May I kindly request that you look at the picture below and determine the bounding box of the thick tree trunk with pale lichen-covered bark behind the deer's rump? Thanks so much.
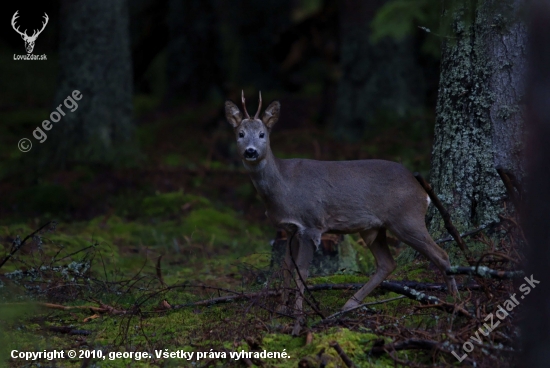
[429,0,526,258]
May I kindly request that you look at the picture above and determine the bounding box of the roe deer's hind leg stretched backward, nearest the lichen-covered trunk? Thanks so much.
[392,218,458,295]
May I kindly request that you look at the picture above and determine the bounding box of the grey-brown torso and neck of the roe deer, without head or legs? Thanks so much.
[250,156,428,234]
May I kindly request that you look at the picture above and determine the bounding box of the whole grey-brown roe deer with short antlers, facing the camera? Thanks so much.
[225,93,458,332]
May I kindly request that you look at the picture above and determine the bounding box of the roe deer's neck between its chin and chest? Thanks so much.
[243,148,283,205]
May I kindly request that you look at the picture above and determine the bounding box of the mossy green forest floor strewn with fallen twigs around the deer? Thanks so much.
[0,90,528,367]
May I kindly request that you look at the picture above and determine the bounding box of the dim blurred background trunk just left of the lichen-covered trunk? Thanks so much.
[333,0,426,140]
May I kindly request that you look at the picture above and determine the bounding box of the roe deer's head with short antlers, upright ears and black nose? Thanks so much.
[225,92,281,165]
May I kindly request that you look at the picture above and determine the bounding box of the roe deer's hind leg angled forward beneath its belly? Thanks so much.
[342,228,396,310]
